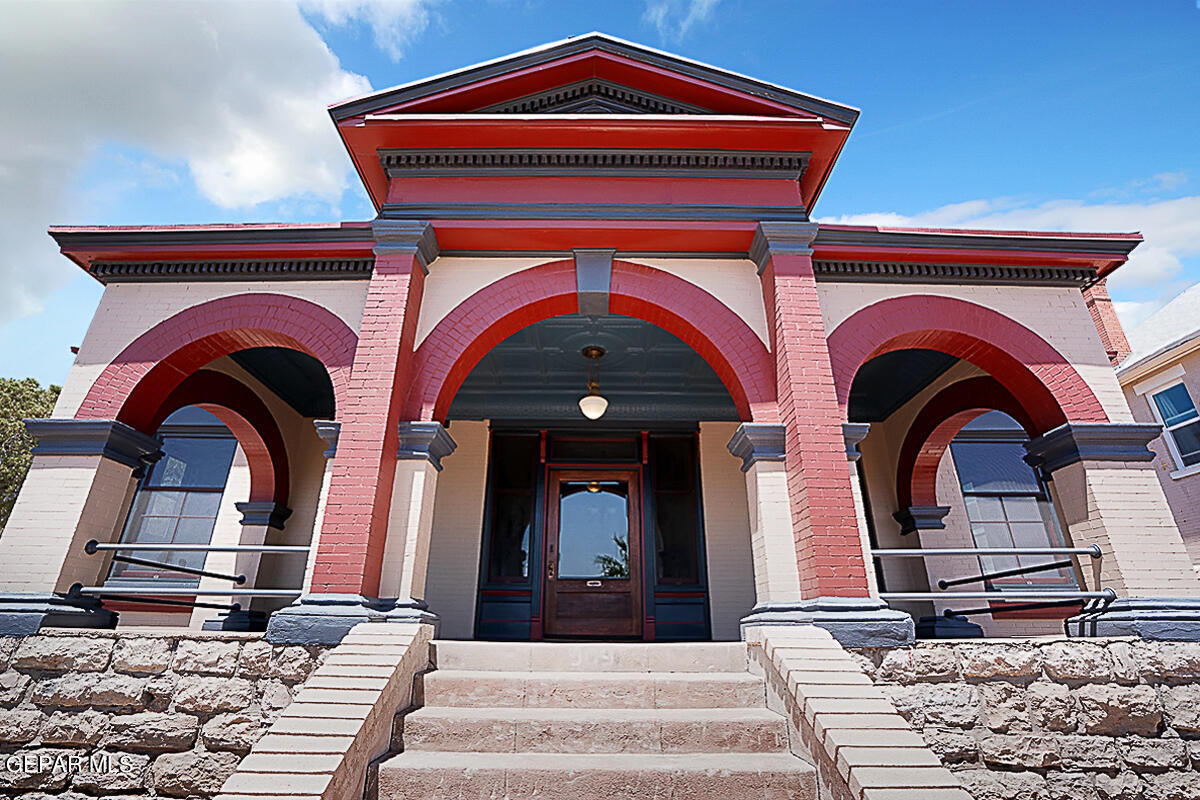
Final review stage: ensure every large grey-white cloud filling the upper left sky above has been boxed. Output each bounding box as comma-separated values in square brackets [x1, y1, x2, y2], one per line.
[0, 0, 433, 325]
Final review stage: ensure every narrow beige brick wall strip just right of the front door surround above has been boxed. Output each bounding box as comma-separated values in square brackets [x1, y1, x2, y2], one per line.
[700, 422, 755, 642]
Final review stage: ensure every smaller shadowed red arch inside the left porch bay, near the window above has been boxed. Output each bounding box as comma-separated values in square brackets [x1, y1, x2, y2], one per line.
[151, 369, 290, 506]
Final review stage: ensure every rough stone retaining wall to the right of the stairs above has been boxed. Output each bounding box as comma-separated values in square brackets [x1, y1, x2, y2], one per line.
[856, 639, 1200, 800]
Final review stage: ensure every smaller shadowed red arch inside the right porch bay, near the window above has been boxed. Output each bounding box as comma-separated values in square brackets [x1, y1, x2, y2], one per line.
[896, 375, 1037, 509]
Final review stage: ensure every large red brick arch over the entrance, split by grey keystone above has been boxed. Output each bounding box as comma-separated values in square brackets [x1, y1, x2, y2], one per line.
[406, 260, 775, 420]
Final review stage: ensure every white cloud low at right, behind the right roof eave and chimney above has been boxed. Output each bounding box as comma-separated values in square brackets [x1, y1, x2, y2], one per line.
[822, 194, 1200, 303]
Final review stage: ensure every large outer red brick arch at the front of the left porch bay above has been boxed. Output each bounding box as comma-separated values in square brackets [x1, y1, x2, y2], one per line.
[76, 294, 358, 433]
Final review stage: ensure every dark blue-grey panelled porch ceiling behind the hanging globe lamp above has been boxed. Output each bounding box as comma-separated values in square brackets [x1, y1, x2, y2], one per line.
[449, 314, 738, 426]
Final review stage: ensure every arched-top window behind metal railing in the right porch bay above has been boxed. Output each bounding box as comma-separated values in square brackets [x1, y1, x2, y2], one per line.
[950, 411, 1076, 589]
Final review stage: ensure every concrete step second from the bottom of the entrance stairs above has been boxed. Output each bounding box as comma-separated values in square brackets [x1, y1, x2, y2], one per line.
[401, 706, 787, 753]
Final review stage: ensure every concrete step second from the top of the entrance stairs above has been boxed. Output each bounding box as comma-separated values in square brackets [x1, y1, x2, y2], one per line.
[419, 669, 766, 709]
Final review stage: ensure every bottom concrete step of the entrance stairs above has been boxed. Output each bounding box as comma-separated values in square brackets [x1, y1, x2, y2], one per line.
[378, 751, 817, 800]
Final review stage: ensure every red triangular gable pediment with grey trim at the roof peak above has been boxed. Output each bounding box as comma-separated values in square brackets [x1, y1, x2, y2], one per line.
[330, 34, 858, 126]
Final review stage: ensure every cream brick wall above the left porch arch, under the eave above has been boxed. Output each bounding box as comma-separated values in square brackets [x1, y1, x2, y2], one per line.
[54, 281, 367, 417]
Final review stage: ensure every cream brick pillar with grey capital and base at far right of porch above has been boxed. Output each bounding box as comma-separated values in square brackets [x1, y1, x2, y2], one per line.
[1026, 423, 1200, 640]
